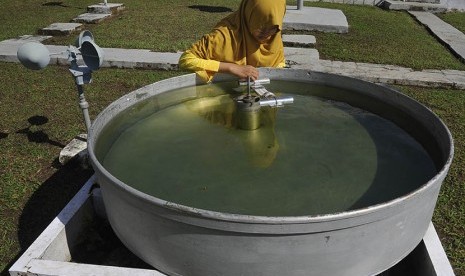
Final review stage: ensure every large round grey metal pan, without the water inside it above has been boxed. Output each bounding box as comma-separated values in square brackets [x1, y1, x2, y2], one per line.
[88, 68, 453, 276]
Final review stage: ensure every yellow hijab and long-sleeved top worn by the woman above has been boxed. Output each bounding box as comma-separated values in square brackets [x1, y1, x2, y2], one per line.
[190, 0, 286, 71]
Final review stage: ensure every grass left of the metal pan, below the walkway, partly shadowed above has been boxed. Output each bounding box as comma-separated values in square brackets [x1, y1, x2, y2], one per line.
[0, 63, 182, 272]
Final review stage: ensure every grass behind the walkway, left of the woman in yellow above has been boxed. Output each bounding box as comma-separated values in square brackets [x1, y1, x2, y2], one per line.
[0, 0, 240, 52]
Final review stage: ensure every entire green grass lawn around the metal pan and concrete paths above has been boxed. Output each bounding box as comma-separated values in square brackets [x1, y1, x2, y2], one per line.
[0, 0, 465, 275]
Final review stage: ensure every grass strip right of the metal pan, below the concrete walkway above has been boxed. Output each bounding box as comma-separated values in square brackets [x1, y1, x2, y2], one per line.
[401, 87, 465, 275]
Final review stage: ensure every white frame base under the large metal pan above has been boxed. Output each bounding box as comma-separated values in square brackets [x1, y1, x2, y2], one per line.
[9, 176, 455, 276]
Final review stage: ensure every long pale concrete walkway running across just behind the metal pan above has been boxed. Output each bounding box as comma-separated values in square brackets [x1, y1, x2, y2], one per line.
[0, 38, 465, 89]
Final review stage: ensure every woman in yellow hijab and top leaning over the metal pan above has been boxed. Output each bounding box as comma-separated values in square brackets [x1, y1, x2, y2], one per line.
[179, 0, 286, 82]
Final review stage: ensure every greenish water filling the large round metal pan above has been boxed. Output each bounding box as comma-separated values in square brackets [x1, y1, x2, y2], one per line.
[103, 82, 435, 216]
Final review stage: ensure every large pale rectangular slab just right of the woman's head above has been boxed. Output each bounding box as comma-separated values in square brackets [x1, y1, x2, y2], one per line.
[283, 6, 349, 33]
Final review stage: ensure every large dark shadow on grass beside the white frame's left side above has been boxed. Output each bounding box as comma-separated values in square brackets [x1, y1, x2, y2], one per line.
[0, 160, 93, 276]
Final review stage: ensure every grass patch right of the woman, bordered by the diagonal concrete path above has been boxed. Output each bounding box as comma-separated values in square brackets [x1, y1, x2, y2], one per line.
[305, 2, 465, 70]
